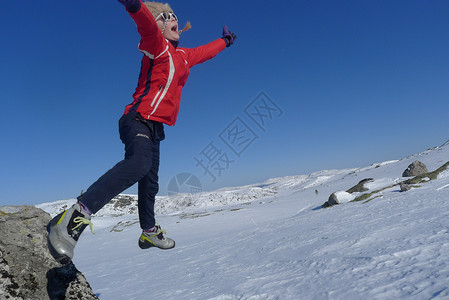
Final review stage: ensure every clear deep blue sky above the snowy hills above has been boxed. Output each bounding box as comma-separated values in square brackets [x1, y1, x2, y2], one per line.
[0, 0, 449, 205]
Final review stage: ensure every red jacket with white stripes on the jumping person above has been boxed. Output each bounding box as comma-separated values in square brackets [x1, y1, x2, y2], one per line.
[125, 5, 226, 126]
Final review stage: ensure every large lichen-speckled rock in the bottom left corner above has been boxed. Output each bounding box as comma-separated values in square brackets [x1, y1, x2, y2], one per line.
[0, 206, 98, 300]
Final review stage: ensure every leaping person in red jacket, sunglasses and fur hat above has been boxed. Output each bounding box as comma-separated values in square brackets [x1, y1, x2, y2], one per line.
[48, 0, 236, 264]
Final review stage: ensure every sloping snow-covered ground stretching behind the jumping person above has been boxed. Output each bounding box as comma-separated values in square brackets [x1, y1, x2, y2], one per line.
[39, 143, 449, 300]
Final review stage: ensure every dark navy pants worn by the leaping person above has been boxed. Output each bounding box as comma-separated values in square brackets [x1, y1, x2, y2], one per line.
[78, 112, 165, 229]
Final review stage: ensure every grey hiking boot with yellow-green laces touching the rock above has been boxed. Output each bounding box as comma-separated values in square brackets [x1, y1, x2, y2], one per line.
[47, 203, 93, 265]
